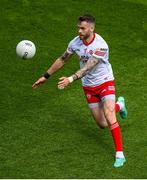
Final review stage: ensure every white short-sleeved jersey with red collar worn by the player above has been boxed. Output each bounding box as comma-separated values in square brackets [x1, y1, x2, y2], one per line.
[67, 33, 114, 87]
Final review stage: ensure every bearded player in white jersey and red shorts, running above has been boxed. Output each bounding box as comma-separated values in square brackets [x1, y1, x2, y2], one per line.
[32, 15, 127, 167]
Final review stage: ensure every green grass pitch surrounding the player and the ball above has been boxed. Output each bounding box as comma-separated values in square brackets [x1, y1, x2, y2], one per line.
[0, 0, 147, 179]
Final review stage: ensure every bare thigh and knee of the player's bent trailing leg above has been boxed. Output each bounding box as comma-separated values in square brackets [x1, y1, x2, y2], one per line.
[90, 105, 108, 128]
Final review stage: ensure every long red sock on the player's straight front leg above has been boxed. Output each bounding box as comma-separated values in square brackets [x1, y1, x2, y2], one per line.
[110, 122, 123, 151]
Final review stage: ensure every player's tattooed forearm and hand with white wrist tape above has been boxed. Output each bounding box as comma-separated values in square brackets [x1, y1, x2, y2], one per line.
[58, 57, 99, 89]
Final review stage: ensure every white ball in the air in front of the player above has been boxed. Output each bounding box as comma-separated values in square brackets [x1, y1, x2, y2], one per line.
[16, 40, 36, 59]
